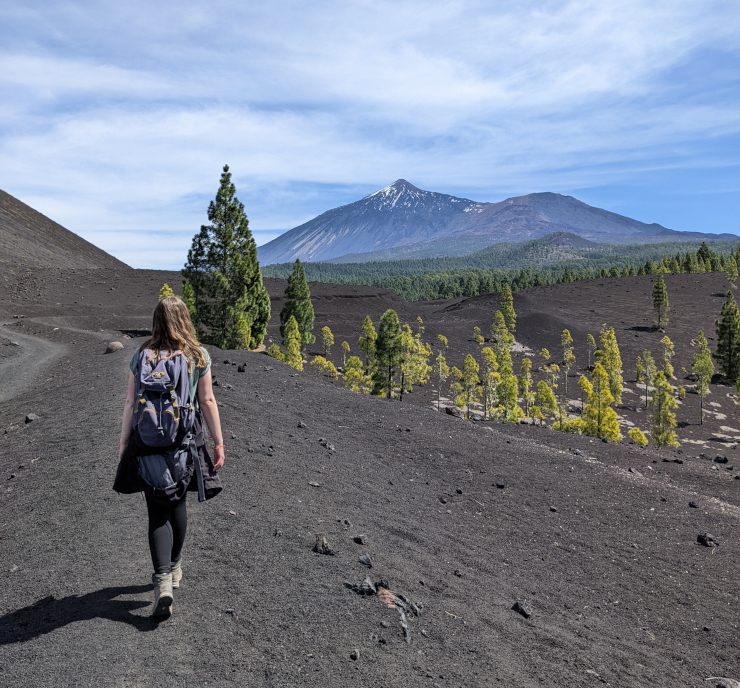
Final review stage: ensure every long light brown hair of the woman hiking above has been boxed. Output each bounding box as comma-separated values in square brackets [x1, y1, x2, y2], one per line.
[139, 296, 207, 374]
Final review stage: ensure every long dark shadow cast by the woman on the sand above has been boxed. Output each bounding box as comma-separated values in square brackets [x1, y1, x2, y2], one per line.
[0, 585, 158, 646]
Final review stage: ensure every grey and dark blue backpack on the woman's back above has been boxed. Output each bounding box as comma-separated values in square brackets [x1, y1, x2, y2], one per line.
[131, 349, 195, 449]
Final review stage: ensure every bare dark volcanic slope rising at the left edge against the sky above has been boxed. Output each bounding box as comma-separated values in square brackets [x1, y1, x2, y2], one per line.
[0, 191, 130, 273]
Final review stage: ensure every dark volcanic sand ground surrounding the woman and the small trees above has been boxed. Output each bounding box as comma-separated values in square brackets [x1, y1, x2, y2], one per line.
[0, 268, 740, 687]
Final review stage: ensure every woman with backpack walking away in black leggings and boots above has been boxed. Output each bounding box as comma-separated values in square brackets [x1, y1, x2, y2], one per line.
[113, 296, 224, 618]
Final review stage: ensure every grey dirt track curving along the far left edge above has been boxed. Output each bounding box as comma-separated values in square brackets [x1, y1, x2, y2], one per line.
[0, 320, 67, 402]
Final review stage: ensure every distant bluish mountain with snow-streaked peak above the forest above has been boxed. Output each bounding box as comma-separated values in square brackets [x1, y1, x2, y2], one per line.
[258, 179, 736, 265]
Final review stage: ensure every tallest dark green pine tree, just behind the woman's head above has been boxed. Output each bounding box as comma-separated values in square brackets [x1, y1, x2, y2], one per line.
[182, 165, 270, 349]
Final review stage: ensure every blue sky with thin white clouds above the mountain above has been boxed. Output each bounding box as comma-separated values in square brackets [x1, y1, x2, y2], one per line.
[0, 0, 740, 269]
